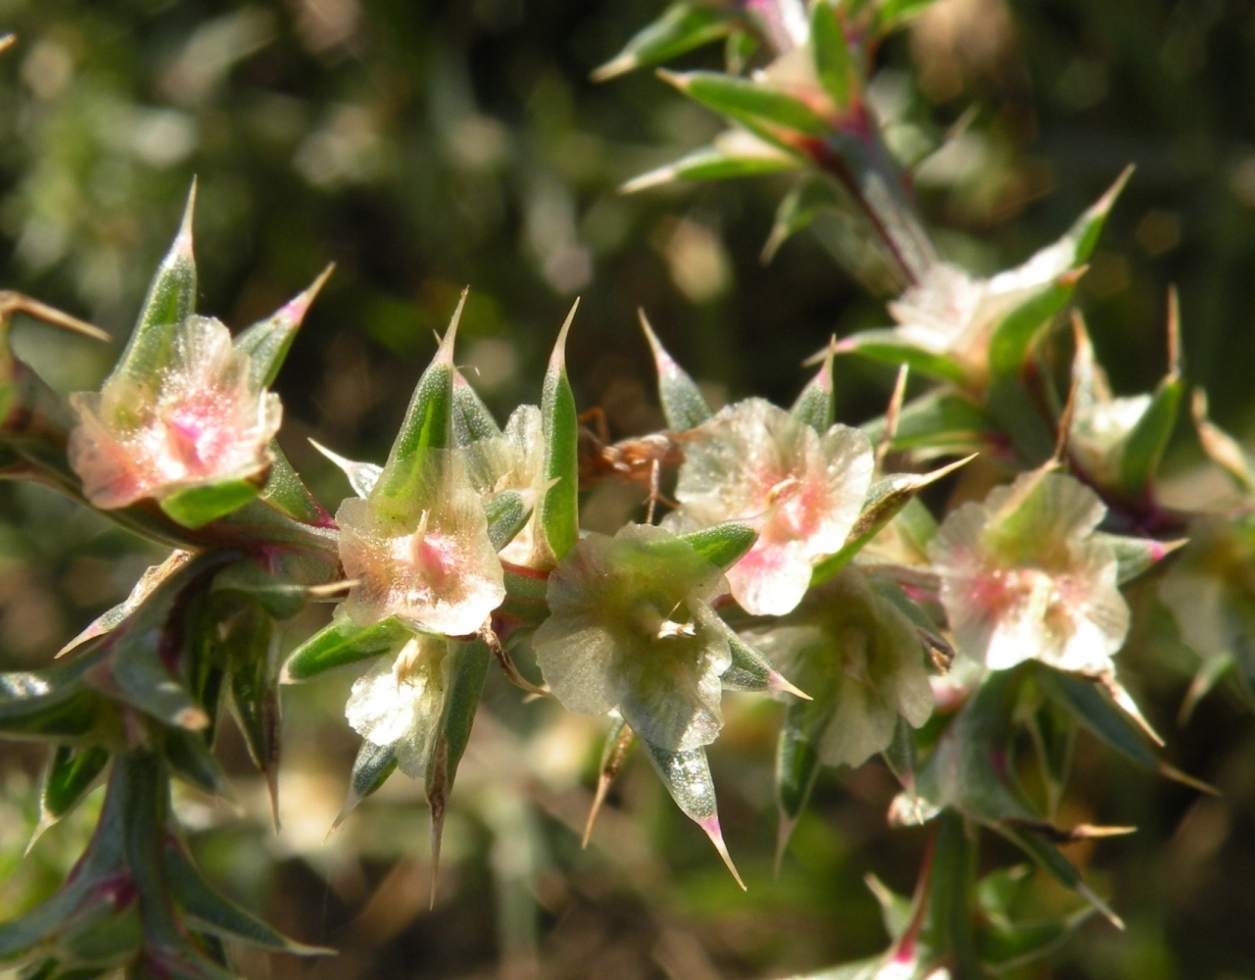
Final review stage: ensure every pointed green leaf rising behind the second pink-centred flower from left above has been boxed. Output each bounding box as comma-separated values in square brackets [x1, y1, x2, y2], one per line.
[371, 291, 467, 498]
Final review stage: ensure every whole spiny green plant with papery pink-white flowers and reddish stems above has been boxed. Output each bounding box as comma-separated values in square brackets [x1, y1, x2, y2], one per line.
[0, 0, 1239, 977]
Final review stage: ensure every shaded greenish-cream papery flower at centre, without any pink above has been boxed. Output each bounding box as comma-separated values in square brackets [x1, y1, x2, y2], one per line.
[532, 525, 732, 752]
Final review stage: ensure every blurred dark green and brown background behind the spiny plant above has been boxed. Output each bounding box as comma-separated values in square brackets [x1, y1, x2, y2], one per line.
[0, 0, 1255, 980]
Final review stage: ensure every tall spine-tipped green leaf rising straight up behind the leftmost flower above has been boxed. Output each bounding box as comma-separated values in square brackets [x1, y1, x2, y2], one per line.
[114, 181, 196, 381]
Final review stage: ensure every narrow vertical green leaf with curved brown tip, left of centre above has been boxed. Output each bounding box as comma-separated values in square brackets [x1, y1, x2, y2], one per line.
[538, 302, 580, 562]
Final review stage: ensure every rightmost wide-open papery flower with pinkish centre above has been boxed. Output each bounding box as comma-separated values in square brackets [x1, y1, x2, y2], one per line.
[929, 469, 1128, 674]
